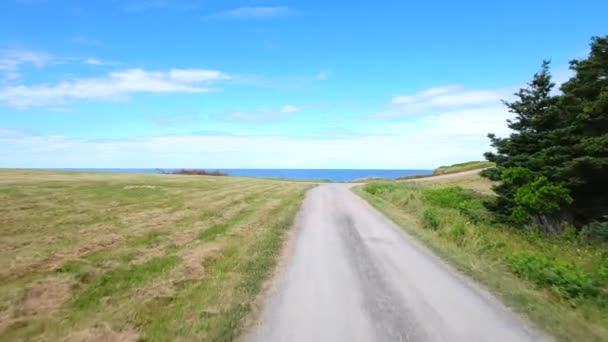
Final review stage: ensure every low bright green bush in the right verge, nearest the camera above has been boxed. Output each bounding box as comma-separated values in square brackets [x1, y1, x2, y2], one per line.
[507, 253, 598, 298]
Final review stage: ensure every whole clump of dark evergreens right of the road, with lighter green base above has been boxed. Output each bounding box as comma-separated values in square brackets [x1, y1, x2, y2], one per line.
[483, 36, 608, 232]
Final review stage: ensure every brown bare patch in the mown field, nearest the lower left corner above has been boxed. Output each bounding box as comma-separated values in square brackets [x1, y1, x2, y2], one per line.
[15, 278, 70, 316]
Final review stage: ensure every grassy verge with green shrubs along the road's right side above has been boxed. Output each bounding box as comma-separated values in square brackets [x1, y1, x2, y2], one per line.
[355, 175, 608, 341]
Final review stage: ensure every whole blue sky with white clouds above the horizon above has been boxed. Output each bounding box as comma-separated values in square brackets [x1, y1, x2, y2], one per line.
[0, 0, 608, 168]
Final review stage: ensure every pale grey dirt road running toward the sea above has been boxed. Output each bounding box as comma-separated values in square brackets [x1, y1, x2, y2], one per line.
[245, 184, 544, 342]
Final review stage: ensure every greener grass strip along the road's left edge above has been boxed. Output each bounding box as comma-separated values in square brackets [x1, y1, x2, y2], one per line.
[138, 190, 305, 341]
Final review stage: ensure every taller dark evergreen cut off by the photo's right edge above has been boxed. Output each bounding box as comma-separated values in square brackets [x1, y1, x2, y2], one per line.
[556, 36, 608, 223]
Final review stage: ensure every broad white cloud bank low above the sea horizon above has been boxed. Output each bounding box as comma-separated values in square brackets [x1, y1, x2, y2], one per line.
[0, 100, 511, 168]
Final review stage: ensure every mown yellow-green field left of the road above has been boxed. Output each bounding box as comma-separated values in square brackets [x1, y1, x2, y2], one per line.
[0, 170, 312, 341]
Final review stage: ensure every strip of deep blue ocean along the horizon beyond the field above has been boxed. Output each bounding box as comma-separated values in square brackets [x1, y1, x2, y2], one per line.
[45, 168, 433, 182]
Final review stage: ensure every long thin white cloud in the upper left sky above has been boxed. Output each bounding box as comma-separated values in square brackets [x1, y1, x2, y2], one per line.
[0, 69, 230, 109]
